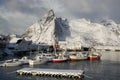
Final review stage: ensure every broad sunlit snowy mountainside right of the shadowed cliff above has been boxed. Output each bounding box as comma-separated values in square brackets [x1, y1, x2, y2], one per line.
[69, 19, 120, 46]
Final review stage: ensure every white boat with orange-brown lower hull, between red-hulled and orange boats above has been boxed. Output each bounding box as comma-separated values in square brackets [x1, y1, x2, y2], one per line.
[69, 52, 88, 61]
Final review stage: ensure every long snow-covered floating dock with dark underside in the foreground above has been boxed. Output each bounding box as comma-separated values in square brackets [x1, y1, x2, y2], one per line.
[16, 68, 84, 80]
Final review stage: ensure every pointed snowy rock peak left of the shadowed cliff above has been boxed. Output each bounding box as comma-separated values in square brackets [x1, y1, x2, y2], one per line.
[23, 10, 55, 44]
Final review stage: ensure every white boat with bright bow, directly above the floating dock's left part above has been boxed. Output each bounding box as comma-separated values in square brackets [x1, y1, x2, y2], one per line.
[29, 56, 48, 65]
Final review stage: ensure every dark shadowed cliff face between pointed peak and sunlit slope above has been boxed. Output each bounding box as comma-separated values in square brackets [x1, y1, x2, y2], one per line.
[55, 18, 71, 41]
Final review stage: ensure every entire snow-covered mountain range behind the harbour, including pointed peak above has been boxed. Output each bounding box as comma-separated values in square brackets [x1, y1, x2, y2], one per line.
[23, 10, 120, 46]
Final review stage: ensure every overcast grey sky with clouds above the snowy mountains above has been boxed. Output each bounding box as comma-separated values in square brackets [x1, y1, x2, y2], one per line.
[0, 0, 120, 34]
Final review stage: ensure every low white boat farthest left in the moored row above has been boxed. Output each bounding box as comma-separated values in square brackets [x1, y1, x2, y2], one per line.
[1, 59, 22, 67]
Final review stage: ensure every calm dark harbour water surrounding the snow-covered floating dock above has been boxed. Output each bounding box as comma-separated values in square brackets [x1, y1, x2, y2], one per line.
[0, 52, 120, 80]
